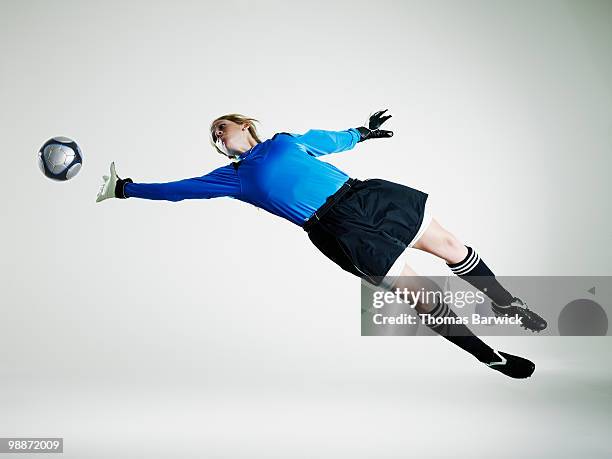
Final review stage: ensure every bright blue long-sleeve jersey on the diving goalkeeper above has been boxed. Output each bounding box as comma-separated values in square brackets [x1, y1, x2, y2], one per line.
[124, 129, 360, 226]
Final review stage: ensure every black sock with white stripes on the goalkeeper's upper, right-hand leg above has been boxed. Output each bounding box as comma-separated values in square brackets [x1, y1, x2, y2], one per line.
[447, 245, 514, 306]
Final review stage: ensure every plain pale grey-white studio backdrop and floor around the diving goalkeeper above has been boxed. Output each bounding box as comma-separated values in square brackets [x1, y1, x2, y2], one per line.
[0, 0, 612, 458]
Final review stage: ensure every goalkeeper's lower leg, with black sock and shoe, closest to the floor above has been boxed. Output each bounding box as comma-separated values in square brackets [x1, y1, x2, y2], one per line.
[389, 265, 535, 378]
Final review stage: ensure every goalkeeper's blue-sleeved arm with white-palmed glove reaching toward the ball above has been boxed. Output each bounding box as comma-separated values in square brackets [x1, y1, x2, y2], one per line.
[96, 163, 240, 202]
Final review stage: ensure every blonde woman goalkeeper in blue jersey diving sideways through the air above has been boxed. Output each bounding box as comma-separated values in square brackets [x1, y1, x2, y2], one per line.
[97, 110, 546, 378]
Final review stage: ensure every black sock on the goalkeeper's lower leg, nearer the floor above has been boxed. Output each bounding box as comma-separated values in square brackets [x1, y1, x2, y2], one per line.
[421, 301, 499, 363]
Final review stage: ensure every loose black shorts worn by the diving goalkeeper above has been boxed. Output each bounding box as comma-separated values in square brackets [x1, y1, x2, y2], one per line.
[304, 179, 428, 286]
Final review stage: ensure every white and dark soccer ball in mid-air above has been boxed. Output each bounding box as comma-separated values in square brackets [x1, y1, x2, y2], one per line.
[38, 137, 83, 181]
